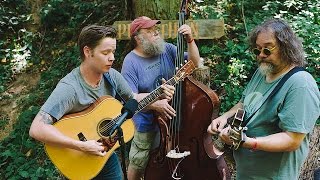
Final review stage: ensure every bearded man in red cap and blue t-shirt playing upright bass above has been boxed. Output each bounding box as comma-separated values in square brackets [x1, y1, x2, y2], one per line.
[121, 16, 200, 180]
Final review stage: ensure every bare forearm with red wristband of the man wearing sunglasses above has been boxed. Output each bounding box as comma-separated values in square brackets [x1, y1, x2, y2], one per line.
[242, 132, 305, 152]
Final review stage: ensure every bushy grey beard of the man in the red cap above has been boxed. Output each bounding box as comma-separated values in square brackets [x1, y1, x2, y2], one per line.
[138, 34, 165, 56]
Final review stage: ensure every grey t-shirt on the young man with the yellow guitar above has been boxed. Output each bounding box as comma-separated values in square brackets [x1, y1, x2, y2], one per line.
[41, 67, 133, 120]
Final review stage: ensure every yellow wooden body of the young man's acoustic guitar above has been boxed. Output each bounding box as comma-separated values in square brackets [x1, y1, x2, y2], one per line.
[45, 96, 134, 180]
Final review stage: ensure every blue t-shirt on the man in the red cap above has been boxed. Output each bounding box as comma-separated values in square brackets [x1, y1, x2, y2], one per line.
[121, 43, 186, 132]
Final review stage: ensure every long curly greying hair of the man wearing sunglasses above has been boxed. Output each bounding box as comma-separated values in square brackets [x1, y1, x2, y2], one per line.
[249, 19, 306, 67]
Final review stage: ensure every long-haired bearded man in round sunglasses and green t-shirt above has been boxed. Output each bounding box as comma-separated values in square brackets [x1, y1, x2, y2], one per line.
[208, 19, 320, 180]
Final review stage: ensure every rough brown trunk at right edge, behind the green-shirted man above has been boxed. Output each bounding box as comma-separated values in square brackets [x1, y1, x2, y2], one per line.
[299, 125, 320, 180]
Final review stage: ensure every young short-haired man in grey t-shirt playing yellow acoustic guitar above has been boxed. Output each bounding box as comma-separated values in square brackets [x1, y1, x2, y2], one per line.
[29, 25, 174, 180]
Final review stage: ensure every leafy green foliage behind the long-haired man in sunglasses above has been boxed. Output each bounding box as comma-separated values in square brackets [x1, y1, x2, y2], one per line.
[193, 0, 320, 113]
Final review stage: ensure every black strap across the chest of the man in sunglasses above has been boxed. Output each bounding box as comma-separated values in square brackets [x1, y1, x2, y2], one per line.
[243, 67, 305, 127]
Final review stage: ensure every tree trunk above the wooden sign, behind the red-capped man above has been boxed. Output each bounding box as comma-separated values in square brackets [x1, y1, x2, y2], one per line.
[132, 0, 180, 20]
